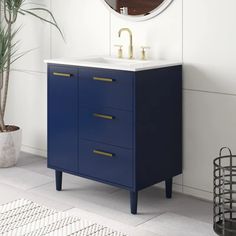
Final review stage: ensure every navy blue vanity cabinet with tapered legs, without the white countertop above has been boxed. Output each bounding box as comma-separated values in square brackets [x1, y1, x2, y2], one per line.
[48, 64, 182, 214]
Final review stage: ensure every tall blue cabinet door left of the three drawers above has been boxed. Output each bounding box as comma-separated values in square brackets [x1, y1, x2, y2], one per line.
[48, 66, 78, 172]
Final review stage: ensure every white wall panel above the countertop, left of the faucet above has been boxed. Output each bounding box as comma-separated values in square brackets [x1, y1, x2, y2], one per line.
[51, 0, 110, 58]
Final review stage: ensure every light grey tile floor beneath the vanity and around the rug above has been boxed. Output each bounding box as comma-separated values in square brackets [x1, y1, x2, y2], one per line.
[0, 153, 218, 236]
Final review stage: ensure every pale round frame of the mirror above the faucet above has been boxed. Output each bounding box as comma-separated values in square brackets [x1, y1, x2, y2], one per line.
[101, 0, 174, 21]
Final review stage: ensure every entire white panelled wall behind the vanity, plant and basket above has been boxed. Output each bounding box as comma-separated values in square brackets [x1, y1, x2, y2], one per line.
[7, 0, 236, 199]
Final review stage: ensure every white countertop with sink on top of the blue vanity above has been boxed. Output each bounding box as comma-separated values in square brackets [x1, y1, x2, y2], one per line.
[44, 56, 182, 71]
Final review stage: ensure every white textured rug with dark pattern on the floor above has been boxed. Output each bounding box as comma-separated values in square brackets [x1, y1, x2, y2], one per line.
[0, 199, 127, 236]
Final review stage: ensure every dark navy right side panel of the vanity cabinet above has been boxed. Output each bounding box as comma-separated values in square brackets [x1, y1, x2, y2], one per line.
[135, 66, 182, 190]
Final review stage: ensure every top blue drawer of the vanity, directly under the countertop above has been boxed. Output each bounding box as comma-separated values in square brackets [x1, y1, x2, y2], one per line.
[79, 68, 134, 110]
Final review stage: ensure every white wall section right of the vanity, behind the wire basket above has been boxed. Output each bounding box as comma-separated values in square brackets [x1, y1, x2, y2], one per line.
[183, 0, 236, 199]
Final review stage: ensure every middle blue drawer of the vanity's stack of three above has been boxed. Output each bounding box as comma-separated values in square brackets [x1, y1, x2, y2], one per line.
[79, 106, 133, 148]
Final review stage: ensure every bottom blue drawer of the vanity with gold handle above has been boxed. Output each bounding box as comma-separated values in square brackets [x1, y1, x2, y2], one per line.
[79, 140, 133, 187]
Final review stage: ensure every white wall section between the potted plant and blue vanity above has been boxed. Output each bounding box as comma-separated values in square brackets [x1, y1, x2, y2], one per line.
[6, 0, 50, 156]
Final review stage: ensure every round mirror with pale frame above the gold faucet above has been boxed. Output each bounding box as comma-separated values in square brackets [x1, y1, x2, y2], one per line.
[102, 0, 173, 21]
